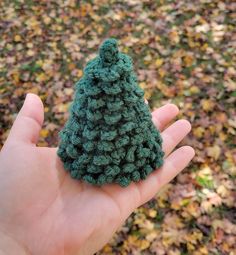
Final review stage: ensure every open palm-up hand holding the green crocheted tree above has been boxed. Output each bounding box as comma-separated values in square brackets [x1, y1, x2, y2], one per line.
[0, 94, 194, 255]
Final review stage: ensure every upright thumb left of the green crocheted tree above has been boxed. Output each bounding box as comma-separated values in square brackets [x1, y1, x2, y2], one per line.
[7, 93, 44, 144]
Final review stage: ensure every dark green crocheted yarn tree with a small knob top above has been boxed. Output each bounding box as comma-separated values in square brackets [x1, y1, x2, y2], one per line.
[58, 38, 164, 187]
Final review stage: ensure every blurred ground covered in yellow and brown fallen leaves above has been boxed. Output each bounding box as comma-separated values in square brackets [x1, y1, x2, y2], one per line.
[0, 0, 236, 255]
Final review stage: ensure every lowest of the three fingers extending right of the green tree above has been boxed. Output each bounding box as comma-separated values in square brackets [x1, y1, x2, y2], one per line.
[137, 146, 195, 205]
